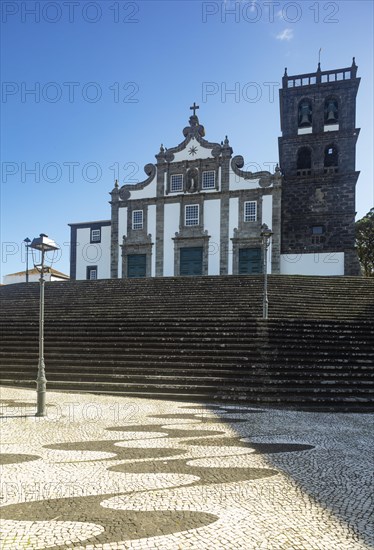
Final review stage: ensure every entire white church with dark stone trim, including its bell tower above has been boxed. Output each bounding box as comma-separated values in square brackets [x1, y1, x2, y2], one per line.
[70, 60, 360, 279]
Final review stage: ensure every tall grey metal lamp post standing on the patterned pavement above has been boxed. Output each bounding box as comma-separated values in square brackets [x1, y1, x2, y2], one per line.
[30, 233, 58, 416]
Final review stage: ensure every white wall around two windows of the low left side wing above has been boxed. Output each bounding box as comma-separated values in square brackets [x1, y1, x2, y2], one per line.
[76, 226, 110, 279]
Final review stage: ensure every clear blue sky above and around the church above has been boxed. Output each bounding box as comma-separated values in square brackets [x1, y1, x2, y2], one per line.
[1, 0, 374, 275]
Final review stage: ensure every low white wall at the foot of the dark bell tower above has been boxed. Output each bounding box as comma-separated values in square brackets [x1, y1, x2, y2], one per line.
[280, 252, 344, 276]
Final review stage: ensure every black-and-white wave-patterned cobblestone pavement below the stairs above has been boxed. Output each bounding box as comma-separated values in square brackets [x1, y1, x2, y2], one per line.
[0, 388, 374, 550]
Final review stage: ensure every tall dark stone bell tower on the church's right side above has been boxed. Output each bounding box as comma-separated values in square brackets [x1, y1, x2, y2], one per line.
[279, 58, 360, 275]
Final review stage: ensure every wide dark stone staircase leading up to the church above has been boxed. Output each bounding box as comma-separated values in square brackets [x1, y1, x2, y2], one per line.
[0, 275, 374, 411]
